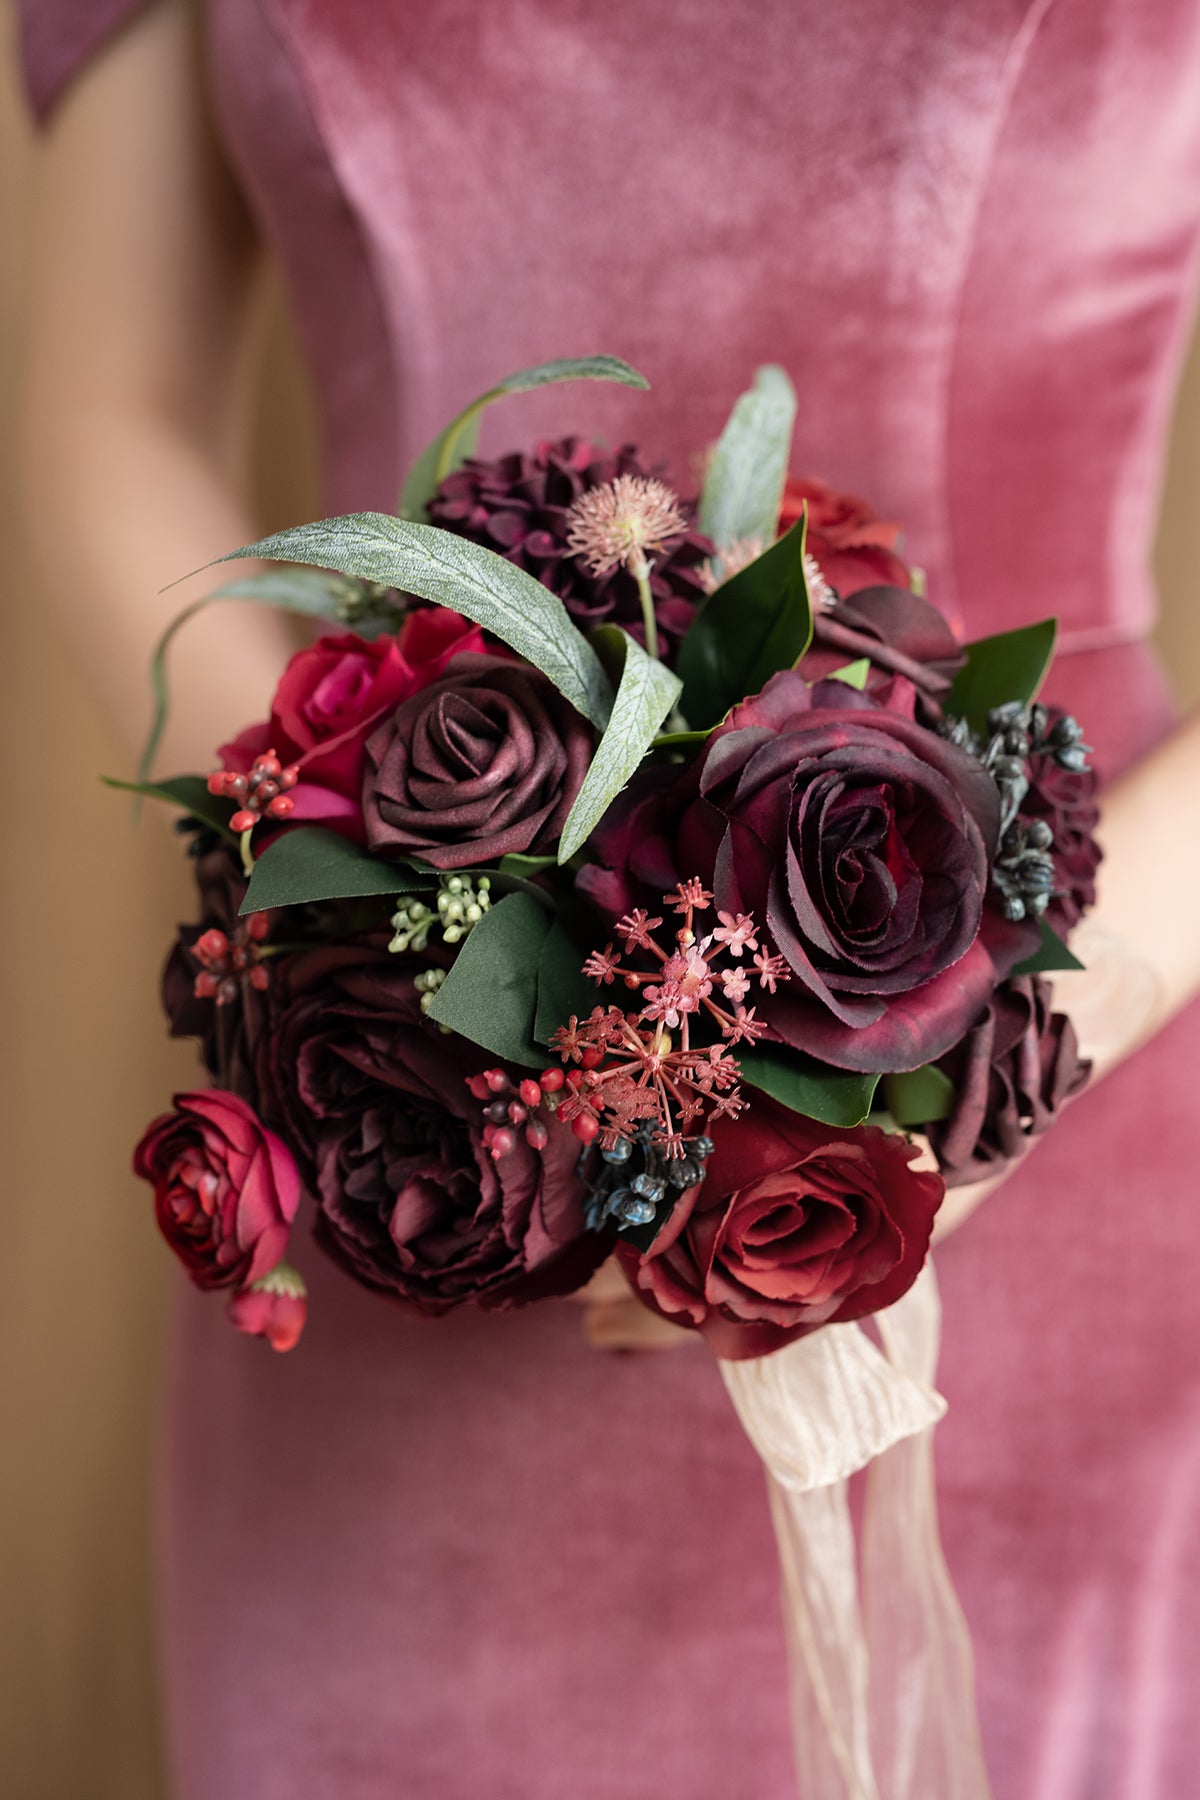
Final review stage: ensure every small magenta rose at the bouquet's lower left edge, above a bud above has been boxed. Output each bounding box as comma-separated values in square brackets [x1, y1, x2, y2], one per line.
[133, 1087, 300, 1287]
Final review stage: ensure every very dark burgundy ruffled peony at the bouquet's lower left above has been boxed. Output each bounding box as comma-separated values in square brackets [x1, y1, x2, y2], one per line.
[259, 947, 606, 1314]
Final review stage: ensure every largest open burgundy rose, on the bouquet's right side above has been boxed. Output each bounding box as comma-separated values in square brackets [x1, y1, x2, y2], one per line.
[579, 670, 999, 1071]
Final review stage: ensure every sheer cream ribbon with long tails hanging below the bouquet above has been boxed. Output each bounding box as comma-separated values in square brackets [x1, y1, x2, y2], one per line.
[720, 1262, 991, 1800]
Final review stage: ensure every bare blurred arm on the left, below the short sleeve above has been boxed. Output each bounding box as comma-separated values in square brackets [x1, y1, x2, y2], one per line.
[23, 0, 293, 770]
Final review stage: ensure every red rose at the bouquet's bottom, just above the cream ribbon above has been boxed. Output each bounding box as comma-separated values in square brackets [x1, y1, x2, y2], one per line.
[617, 1094, 945, 1359]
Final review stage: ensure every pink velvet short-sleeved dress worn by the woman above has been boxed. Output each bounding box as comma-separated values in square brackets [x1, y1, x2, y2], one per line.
[16, 0, 1200, 1800]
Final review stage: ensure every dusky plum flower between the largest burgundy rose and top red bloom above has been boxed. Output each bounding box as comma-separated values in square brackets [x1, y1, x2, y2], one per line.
[801, 587, 966, 715]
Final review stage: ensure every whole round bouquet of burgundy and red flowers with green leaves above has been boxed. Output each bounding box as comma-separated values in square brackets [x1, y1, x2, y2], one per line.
[119, 358, 1099, 1793]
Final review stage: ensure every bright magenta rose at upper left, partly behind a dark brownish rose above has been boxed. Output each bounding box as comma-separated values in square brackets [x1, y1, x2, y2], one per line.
[219, 607, 484, 841]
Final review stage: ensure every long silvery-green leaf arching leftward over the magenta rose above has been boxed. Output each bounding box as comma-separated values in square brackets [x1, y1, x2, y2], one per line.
[218, 513, 612, 729]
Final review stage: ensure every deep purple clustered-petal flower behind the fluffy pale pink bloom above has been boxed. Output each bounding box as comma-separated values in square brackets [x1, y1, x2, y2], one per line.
[428, 437, 712, 661]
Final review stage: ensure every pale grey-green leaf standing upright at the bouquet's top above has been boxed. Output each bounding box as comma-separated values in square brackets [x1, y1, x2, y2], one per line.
[698, 364, 795, 547]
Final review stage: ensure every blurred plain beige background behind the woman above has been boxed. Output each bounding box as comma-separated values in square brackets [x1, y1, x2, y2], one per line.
[0, 14, 1200, 1800]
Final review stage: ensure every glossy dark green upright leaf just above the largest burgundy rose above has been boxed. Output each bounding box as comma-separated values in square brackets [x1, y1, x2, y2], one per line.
[675, 520, 813, 727]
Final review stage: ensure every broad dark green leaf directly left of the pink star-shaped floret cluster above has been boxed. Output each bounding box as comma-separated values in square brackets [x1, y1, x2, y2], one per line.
[430, 893, 551, 1067]
